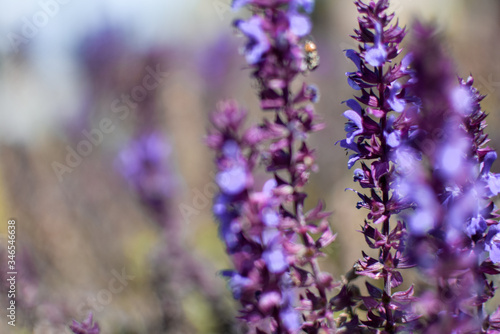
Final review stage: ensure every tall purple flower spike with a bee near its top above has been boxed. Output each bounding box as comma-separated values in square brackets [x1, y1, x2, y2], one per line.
[233, 0, 335, 333]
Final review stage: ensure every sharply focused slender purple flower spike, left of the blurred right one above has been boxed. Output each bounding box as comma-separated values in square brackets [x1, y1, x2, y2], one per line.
[338, 0, 414, 333]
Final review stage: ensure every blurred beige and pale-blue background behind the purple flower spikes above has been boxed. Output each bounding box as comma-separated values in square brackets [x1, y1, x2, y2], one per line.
[0, 0, 500, 334]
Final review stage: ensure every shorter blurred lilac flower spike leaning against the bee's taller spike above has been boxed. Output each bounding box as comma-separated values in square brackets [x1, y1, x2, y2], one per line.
[207, 102, 301, 333]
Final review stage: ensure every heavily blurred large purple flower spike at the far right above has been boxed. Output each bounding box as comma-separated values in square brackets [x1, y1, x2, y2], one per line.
[396, 25, 498, 333]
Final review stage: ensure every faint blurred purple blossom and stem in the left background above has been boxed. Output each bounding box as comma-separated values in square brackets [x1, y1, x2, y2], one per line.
[118, 129, 237, 333]
